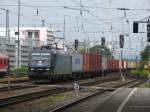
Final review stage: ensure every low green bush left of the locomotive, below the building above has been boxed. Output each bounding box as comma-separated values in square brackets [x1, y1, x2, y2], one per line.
[10, 67, 28, 77]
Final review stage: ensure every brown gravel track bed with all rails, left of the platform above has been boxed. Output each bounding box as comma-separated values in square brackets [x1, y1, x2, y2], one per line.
[0, 73, 145, 112]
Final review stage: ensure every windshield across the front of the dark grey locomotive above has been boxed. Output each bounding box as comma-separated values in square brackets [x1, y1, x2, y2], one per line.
[32, 53, 50, 61]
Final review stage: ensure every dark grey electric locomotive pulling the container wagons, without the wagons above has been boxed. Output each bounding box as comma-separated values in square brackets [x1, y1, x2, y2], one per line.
[28, 46, 71, 81]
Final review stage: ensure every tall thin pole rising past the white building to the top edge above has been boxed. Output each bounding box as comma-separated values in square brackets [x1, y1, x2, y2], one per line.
[17, 0, 20, 68]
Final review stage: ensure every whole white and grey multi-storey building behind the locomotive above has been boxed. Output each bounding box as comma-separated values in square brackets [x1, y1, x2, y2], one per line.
[0, 27, 54, 67]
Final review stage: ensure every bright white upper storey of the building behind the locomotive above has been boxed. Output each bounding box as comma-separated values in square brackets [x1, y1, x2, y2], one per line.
[0, 27, 54, 45]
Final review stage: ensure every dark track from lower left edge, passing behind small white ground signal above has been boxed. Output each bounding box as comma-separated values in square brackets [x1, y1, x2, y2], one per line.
[0, 77, 121, 107]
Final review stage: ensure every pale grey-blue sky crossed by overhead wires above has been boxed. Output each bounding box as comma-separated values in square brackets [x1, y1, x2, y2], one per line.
[0, 0, 150, 58]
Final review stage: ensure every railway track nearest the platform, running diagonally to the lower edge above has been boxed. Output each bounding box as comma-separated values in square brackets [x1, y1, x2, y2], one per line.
[49, 80, 145, 112]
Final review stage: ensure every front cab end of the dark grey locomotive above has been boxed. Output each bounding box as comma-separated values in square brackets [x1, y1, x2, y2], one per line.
[28, 48, 52, 79]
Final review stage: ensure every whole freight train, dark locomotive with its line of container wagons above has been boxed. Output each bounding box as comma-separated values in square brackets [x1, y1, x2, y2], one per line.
[28, 46, 137, 81]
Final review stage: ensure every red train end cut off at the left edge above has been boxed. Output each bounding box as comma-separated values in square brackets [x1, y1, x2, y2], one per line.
[0, 54, 9, 77]
